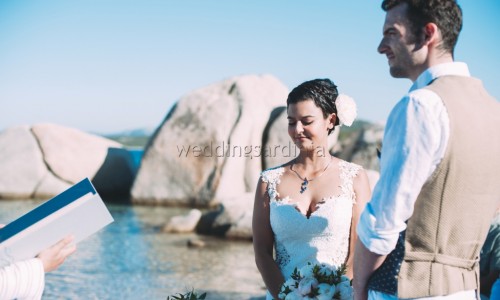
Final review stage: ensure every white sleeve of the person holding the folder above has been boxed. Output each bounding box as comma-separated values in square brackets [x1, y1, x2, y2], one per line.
[0, 258, 45, 300]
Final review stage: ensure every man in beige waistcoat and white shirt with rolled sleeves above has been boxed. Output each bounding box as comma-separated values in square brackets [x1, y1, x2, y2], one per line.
[354, 0, 500, 299]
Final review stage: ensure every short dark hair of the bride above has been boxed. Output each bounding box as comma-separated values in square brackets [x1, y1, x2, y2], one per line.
[286, 79, 339, 134]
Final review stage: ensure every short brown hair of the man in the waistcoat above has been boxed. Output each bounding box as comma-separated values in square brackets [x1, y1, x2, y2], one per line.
[382, 0, 462, 55]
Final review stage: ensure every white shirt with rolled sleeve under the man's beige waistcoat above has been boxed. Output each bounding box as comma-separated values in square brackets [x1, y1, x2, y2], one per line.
[357, 62, 476, 300]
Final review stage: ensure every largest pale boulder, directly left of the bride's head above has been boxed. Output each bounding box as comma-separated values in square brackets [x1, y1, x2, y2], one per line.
[132, 75, 288, 206]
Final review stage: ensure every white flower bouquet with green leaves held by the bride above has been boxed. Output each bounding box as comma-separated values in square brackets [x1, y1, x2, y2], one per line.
[278, 263, 354, 300]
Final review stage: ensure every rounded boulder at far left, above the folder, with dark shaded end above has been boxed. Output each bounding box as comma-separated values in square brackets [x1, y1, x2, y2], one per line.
[0, 123, 135, 198]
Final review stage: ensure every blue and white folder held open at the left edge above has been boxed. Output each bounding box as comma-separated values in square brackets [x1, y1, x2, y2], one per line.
[0, 178, 113, 267]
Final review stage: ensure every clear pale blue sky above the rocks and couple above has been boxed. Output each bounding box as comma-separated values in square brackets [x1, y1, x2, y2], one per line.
[0, 0, 500, 133]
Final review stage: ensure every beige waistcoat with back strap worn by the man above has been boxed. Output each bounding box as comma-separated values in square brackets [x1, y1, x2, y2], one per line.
[398, 76, 500, 298]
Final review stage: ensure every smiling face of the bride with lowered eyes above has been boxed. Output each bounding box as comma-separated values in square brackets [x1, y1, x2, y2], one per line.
[287, 100, 335, 150]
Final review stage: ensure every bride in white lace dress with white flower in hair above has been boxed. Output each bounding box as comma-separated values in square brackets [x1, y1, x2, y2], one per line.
[252, 79, 370, 299]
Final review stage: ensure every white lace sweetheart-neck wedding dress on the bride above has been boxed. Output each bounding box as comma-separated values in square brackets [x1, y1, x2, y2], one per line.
[261, 161, 361, 299]
